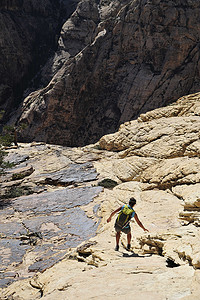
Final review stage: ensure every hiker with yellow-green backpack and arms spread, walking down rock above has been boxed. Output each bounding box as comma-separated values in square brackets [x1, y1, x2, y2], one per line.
[107, 198, 148, 251]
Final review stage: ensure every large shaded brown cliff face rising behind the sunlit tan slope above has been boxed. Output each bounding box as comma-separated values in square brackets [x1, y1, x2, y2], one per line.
[14, 0, 200, 146]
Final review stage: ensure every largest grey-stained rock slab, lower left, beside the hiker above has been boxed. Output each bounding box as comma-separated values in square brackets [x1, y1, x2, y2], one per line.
[0, 187, 102, 288]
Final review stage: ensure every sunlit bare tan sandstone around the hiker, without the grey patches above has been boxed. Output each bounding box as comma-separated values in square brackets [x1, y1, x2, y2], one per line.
[0, 95, 200, 300]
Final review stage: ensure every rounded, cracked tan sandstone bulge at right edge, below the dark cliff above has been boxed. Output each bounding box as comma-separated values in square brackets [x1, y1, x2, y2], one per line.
[99, 115, 200, 158]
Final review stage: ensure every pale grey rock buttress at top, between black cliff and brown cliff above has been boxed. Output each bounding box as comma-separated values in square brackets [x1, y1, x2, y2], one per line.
[42, 0, 99, 79]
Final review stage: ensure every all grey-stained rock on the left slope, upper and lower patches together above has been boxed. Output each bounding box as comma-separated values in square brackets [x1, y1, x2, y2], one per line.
[0, 146, 102, 287]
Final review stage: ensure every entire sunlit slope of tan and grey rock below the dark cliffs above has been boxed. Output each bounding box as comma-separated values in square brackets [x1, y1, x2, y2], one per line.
[0, 93, 200, 300]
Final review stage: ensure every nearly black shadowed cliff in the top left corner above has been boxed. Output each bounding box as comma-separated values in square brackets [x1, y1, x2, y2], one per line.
[0, 0, 76, 118]
